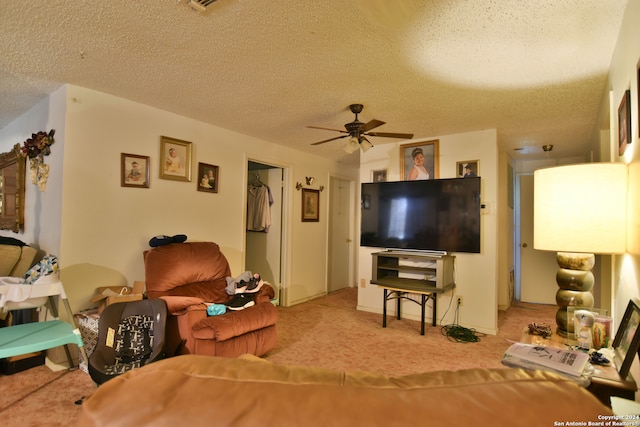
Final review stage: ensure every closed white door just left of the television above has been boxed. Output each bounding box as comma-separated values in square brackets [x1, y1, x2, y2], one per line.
[327, 177, 355, 292]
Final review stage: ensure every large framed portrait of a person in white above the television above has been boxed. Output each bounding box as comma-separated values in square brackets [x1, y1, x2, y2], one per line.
[400, 140, 439, 181]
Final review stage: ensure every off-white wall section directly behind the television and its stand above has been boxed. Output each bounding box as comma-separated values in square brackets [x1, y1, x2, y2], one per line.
[358, 129, 506, 334]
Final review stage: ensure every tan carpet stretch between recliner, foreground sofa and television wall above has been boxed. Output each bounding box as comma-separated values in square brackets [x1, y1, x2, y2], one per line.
[265, 289, 557, 375]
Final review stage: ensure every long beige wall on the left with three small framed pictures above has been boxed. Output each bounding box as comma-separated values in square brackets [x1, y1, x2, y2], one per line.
[0, 85, 357, 310]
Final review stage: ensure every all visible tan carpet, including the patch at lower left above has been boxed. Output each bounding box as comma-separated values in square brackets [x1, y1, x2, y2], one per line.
[0, 288, 556, 426]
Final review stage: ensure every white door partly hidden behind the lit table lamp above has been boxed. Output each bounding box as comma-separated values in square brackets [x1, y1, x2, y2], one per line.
[516, 175, 558, 304]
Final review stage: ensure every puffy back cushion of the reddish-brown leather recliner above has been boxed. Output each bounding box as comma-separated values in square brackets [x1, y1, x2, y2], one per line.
[143, 242, 231, 303]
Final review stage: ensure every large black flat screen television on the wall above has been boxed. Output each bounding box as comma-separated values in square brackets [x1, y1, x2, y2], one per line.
[360, 177, 481, 253]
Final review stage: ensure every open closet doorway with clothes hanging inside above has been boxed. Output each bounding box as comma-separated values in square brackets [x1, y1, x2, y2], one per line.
[244, 160, 285, 303]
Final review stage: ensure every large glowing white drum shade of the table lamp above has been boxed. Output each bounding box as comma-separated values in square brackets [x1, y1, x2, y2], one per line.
[533, 163, 627, 254]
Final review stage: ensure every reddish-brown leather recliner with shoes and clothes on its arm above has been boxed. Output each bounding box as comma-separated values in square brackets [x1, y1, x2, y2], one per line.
[144, 242, 278, 357]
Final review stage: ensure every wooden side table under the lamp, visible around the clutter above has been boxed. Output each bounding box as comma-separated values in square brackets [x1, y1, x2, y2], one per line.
[520, 328, 638, 407]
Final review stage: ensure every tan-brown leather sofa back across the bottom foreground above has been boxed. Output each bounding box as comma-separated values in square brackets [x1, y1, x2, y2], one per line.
[78, 355, 612, 427]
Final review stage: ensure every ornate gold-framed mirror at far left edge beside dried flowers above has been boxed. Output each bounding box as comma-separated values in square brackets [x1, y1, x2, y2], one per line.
[0, 144, 27, 233]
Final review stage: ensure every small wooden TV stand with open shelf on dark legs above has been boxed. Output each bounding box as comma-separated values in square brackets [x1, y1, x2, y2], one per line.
[371, 251, 455, 335]
